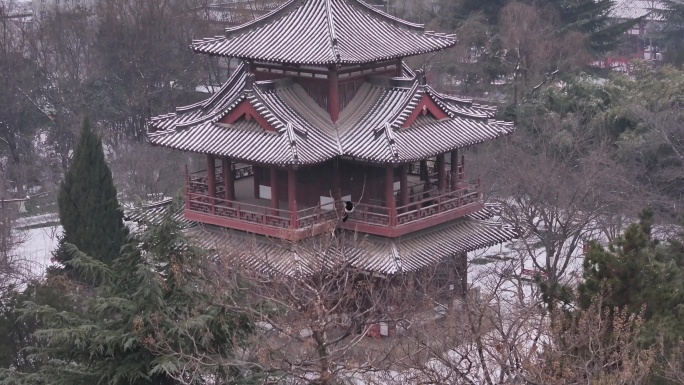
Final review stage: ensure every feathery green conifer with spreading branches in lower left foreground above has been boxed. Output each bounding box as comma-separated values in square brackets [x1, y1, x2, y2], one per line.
[0, 202, 253, 385]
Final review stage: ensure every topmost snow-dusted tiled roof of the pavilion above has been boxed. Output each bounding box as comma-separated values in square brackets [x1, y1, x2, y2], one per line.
[192, 0, 456, 65]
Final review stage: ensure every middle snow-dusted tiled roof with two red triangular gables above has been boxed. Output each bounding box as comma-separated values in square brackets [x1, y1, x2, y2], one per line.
[148, 63, 514, 165]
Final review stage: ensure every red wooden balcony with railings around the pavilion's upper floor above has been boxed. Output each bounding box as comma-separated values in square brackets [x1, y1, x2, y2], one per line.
[185, 166, 483, 239]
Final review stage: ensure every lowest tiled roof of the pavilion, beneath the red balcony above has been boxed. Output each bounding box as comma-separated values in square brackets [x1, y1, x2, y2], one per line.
[126, 200, 519, 275]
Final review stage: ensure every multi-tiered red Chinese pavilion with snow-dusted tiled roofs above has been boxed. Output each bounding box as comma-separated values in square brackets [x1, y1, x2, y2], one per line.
[148, 0, 516, 282]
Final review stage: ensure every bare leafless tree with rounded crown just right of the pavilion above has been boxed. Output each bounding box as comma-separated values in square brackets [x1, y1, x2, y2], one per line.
[484, 111, 643, 300]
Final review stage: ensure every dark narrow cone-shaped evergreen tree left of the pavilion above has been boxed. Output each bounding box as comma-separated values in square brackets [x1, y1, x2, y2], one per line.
[54, 119, 128, 274]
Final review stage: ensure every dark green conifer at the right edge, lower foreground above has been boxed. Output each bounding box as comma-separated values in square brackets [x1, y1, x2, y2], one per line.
[578, 211, 684, 384]
